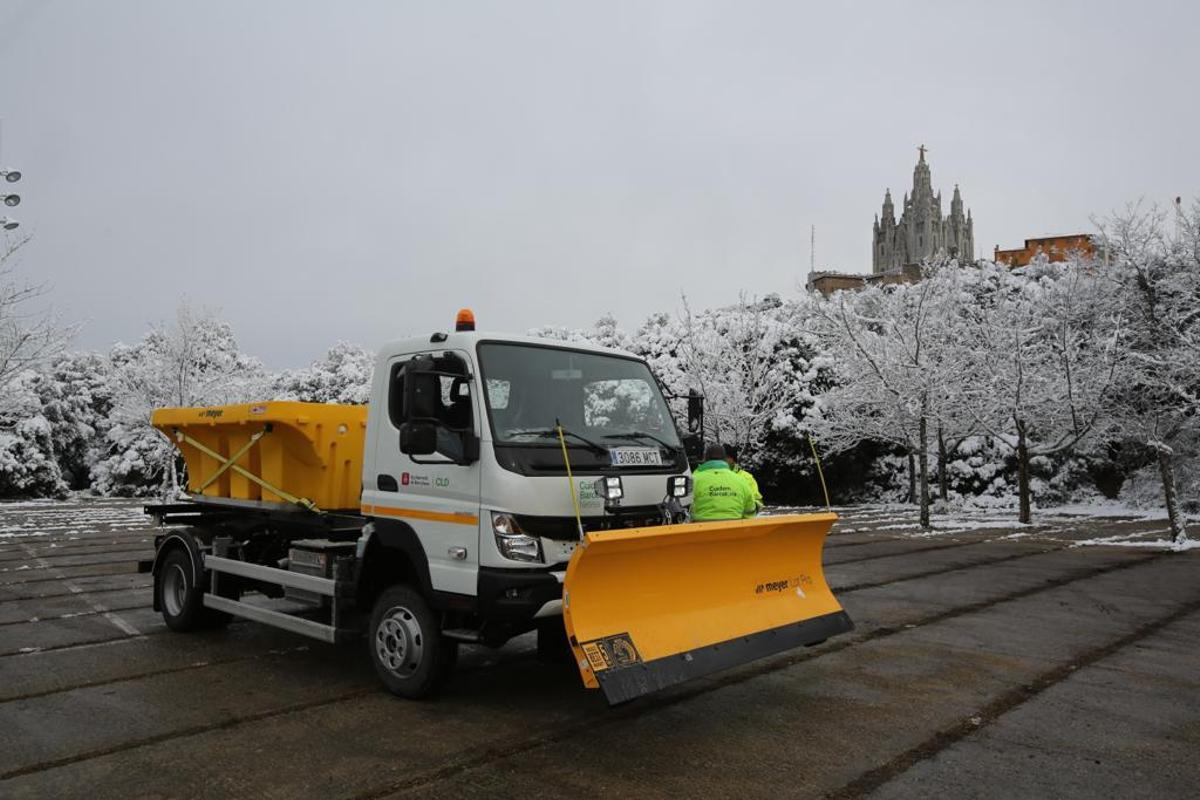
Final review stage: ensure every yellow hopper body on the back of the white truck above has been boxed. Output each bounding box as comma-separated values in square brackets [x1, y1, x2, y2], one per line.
[150, 401, 367, 511]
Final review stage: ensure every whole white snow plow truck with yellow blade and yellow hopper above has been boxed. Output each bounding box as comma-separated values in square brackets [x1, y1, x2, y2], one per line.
[143, 309, 852, 704]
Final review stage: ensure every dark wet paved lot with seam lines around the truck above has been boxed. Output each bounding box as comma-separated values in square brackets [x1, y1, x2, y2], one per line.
[0, 503, 1200, 800]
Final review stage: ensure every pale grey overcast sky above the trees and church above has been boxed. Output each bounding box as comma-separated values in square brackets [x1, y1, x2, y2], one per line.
[0, 0, 1200, 367]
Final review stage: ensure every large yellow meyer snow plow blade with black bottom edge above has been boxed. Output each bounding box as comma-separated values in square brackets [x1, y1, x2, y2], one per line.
[563, 513, 853, 703]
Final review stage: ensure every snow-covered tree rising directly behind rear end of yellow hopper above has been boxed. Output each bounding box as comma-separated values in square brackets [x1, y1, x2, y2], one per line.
[92, 302, 270, 495]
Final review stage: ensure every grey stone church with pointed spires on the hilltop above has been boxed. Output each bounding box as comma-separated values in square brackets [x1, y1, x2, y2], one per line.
[871, 145, 974, 275]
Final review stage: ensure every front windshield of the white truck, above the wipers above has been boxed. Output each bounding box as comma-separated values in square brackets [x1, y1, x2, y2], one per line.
[479, 343, 682, 449]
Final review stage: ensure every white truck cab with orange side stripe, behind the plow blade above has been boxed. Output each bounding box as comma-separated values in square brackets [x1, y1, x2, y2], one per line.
[360, 330, 690, 676]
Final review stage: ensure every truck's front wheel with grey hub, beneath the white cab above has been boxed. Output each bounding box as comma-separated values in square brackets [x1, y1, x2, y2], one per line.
[367, 584, 458, 699]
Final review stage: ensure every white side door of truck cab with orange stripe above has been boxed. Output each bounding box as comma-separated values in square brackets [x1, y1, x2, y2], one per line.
[364, 351, 480, 595]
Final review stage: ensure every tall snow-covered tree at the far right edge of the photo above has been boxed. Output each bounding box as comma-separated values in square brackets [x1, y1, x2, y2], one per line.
[1100, 201, 1200, 542]
